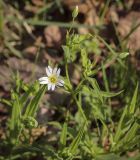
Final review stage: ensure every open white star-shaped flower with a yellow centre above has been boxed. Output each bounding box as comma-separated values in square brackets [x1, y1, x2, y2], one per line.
[39, 66, 64, 91]
